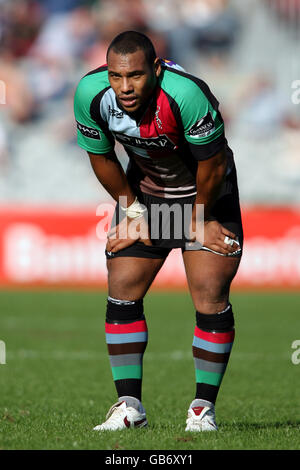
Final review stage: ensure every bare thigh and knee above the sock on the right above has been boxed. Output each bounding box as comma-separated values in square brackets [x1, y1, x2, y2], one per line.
[183, 250, 240, 313]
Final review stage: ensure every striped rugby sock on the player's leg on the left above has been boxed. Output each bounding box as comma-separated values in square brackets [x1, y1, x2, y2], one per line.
[105, 297, 148, 400]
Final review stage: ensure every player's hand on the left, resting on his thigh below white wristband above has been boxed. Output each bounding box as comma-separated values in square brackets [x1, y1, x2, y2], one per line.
[106, 216, 152, 253]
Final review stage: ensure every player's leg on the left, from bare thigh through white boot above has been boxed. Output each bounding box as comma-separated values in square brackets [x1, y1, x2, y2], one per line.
[95, 250, 165, 431]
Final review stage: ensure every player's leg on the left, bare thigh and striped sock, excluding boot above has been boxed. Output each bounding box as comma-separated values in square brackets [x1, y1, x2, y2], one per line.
[106, 253, 164, 400]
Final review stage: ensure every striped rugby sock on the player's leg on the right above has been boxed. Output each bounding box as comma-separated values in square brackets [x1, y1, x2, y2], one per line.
[193, 304, 235, 406]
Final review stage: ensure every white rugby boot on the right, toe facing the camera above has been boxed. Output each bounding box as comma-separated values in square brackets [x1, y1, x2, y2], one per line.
[185, 400, 218, 432]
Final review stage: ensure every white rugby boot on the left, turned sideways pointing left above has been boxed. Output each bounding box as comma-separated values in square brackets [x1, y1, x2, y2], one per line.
[94, 397, 148, 431]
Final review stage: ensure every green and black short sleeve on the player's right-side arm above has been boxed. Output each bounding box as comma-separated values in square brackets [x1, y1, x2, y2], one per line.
[181, 80, 226, 160]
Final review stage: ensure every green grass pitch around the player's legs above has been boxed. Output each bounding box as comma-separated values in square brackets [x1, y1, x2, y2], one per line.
[0, 291, 300, 450]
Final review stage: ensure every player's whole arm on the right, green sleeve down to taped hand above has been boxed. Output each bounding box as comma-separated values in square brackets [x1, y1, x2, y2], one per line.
[181, 81, 236, 254]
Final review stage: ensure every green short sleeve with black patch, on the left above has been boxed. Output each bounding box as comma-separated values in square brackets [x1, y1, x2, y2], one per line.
[74, 78, 114, 154]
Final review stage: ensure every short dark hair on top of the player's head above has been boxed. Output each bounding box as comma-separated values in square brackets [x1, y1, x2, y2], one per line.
[106, 31, 157, 65]
